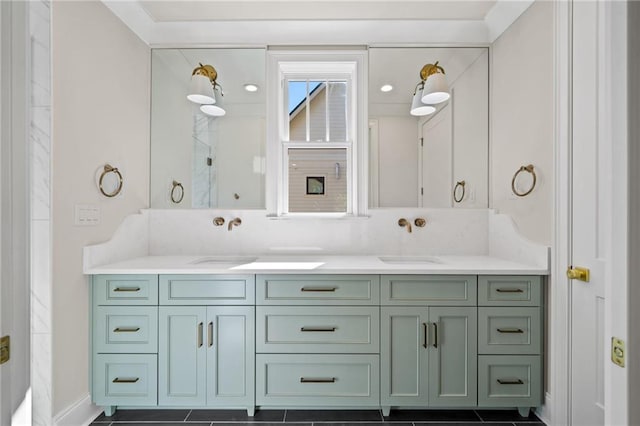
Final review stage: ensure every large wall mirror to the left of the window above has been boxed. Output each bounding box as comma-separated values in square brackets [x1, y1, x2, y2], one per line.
[150, 49, 266, 209]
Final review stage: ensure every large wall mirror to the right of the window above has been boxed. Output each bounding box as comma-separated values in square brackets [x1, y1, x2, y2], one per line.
[369, 48, 489, 208]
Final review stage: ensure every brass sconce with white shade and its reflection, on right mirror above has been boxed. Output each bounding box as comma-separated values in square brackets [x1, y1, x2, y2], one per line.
[409, 61, 451, 116]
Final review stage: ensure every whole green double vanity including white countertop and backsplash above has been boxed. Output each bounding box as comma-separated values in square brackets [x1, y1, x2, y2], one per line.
[84, 209, 549, 415]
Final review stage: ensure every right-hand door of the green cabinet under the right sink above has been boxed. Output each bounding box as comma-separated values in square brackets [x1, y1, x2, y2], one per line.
[429, 307, 478, 407]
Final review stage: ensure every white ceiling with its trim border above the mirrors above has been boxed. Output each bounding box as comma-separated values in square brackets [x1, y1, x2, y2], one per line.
[102, 0, 534, 47]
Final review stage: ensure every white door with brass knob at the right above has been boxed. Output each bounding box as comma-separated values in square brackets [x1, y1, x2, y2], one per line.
[569, 1, 611, 426]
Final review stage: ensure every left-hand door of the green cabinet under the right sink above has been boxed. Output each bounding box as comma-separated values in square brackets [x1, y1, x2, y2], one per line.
[380, 307, 429, 407]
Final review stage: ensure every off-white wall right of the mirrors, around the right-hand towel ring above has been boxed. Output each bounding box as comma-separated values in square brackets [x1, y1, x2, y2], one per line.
[489, 0, 553, 245]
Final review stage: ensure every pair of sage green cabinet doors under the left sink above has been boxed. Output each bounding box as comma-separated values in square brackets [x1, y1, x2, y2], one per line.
[158, 306, 255, 413]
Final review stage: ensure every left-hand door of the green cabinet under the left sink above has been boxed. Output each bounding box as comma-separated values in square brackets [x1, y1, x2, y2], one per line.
[158, 306, 207, 406]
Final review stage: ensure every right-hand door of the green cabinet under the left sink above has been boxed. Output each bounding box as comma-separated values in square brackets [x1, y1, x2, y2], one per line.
[205, 306, 255, 407]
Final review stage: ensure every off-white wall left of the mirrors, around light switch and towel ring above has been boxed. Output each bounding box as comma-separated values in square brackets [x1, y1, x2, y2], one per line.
[51, 1, 150, 415]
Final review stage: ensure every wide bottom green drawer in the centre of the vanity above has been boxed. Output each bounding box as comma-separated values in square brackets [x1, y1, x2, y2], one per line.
[256, 355, 380, 407]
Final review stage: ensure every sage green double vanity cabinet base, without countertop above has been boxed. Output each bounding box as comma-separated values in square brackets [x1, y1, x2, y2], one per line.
[90, 274, 543, 415]
